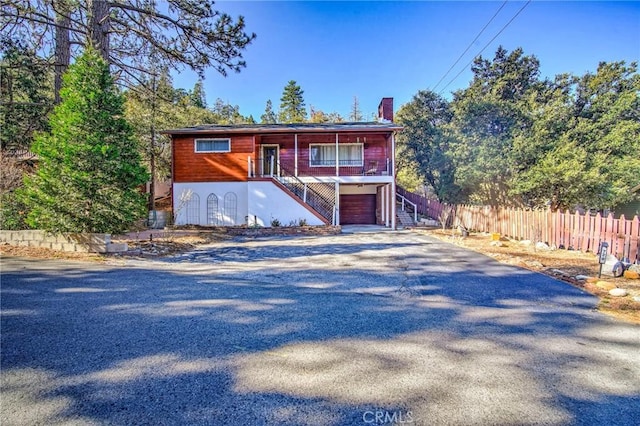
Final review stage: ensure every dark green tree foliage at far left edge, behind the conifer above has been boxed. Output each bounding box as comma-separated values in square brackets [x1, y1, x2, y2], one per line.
[0, 38, 53, 151]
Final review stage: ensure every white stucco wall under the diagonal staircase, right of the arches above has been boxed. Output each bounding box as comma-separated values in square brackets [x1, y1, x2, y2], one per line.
[247, 181, 323, 226]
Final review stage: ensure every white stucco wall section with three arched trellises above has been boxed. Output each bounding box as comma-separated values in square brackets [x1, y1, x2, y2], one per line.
[173, 182, 248, 226]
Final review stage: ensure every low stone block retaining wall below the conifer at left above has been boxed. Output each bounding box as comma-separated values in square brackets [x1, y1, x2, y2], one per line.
[0, 230, 127, 253]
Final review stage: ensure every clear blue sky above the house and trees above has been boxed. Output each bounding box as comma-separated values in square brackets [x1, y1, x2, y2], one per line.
[174, 1, 640, 120]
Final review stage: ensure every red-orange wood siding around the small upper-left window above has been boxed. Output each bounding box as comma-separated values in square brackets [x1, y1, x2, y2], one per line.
[172, 135, 254, 182]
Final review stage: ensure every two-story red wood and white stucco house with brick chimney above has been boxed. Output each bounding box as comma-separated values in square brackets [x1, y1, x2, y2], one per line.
[164, 98, 401, 228]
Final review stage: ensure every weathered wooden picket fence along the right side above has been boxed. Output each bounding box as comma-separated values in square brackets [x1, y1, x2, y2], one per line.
[398, 187, 640, 262]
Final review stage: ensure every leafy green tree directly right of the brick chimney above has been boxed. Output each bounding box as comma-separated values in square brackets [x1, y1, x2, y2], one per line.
[396, 90, 461, 203]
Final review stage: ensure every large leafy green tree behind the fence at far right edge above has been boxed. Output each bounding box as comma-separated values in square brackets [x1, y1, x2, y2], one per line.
[512, 62, 640, 209]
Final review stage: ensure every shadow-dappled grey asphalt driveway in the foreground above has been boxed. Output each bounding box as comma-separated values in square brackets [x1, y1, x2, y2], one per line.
[0, 232, 640, 426]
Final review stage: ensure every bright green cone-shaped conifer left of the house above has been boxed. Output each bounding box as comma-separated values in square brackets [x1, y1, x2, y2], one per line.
[20, 48, 148, 233]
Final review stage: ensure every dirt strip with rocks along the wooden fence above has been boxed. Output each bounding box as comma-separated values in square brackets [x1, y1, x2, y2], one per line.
[415, 229, 640, 323]
